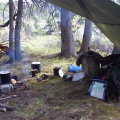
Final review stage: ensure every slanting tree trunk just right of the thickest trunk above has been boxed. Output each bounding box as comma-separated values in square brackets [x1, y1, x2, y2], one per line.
[80, 19, 92, 52]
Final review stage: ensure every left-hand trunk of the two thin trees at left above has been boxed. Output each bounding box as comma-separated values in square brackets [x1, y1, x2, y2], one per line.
[9, 0, 15, 63]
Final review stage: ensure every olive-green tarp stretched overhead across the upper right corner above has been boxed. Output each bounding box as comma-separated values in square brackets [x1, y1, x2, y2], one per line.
[45, 0, 120, 49]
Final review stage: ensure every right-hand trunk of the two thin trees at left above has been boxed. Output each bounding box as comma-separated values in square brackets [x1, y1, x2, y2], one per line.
[15, 0, 23, 61]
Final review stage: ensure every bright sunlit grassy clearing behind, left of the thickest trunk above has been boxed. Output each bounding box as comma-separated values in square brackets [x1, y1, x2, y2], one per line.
[22, 35, 60, 55]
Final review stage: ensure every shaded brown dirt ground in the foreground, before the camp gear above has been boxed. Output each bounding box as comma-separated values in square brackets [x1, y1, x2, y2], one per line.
[0, 75, 120, 120]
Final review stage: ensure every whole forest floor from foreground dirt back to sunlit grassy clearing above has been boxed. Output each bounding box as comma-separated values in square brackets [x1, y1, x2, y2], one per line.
[0, 37, 120, 120]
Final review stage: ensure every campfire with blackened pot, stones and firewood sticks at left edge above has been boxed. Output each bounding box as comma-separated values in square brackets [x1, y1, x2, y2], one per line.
[0, 71, 29, 112]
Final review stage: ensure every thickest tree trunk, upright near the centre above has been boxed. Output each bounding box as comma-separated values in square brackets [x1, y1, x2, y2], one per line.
[61, 9, 75, 57]
